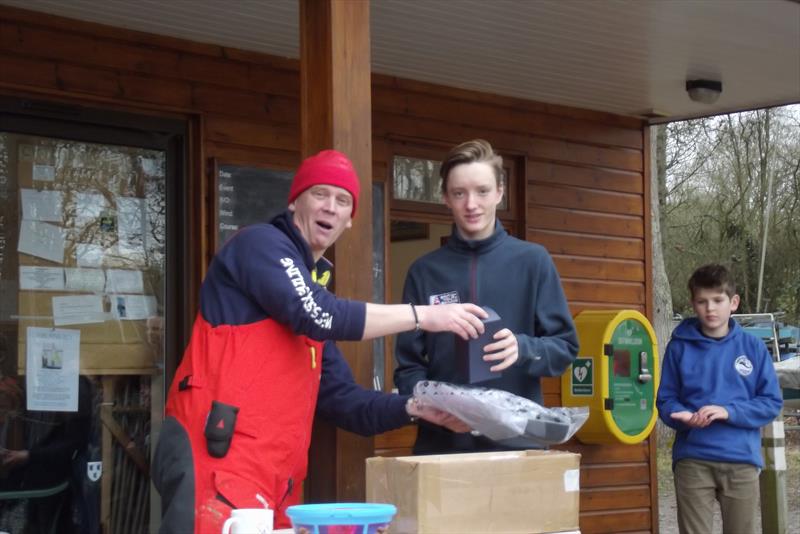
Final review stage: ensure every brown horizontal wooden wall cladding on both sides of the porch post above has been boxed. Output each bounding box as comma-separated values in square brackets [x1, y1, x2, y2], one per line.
[0, 7, 658, 534]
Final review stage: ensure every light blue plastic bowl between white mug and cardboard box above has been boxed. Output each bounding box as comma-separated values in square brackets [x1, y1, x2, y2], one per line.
[286, 503, 397, 534]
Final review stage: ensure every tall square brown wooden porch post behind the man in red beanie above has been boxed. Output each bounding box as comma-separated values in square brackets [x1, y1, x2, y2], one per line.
[300, 0, 373, 502]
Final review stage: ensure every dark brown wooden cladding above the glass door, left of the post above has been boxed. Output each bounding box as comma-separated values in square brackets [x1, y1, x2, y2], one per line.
[0, 7, 300, 171]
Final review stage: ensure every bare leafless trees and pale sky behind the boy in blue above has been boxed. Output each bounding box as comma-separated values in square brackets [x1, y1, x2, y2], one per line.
[656, 106, 800, 321]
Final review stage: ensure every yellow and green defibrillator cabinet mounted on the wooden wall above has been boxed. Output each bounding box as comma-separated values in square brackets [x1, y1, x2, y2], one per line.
[561, 310, 659, 444]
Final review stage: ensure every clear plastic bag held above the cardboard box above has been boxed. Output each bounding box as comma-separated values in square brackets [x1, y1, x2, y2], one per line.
[414, 380, 589, 448]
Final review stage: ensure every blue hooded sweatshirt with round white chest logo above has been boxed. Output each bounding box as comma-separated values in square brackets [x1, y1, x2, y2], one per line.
[656, 318, 783, 467]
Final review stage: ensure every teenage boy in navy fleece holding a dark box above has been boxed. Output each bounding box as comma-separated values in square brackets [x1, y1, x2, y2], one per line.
[394, 139, 578, 454]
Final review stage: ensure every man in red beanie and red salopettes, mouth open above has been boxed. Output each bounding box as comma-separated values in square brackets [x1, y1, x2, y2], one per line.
[153, 150, 486, 534]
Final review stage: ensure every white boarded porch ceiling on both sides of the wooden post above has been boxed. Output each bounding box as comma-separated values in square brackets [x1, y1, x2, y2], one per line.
[0, 0, 800, 120]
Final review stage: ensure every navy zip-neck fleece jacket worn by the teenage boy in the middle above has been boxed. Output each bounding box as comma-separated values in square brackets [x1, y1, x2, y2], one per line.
[394, 221, 578, 454]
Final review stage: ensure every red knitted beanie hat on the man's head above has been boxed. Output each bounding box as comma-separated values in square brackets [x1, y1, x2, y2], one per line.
[289, 150, 361, 217]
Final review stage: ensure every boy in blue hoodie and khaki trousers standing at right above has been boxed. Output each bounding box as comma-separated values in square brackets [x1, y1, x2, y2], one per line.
[656, 265, 783, 534]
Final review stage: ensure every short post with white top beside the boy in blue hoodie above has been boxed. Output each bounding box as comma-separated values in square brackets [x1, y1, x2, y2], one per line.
[759, 411, 788, 534]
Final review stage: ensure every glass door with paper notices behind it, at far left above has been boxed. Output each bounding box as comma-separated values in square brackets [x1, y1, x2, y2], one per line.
[0, 97, 186, 534]
